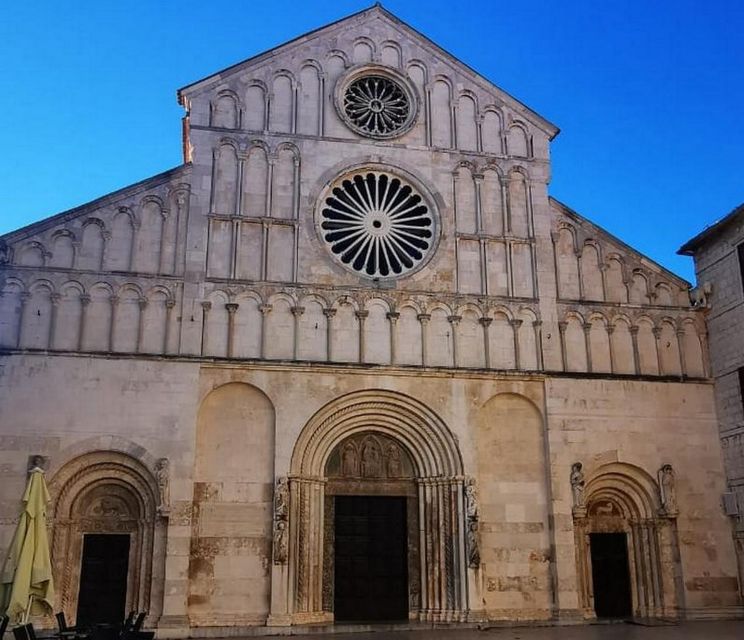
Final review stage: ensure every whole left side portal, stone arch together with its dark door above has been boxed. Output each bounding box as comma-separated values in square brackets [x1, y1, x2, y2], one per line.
[50, 451, 167, 625]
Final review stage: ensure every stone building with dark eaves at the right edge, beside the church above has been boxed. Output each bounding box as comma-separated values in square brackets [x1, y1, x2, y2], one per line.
[679, 205, 744, 600]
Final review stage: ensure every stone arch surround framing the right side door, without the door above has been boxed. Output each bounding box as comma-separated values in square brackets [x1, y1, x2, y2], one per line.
[573, 462, 680, 618]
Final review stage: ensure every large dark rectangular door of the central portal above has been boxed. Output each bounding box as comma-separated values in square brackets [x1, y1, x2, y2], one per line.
[334, 496, 408, 622]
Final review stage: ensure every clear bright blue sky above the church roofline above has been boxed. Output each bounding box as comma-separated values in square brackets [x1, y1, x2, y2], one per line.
[0, 0, 744, 279]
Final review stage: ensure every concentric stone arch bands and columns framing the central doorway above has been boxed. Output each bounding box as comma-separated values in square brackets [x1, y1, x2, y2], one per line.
[282, 390, 470, 624]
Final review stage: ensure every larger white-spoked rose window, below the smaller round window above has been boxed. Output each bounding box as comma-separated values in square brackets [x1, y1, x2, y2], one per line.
[316, 167, 437, 279]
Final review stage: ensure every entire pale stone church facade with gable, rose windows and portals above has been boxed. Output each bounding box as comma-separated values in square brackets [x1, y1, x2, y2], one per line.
[0, 6, 741, 637]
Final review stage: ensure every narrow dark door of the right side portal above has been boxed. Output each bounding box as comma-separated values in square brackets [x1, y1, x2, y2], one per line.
[589, 533, 633, 618]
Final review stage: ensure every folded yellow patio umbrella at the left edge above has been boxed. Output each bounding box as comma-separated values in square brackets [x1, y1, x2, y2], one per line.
[0, 469, 54, 624]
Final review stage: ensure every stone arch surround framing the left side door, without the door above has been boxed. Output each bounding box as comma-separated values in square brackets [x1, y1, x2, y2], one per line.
[49, 451, 167, 626]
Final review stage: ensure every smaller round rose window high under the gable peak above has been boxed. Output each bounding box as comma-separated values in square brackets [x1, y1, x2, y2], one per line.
[335, 65, 419, 140]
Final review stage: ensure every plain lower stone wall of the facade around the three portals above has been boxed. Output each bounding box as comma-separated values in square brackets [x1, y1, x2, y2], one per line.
[0, 355, 737, 626]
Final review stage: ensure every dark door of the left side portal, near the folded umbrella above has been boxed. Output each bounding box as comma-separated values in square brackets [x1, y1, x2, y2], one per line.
[76, 534, 129, 626]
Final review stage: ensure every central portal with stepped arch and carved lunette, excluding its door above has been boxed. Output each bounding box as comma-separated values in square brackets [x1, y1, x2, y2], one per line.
[288, 390, 468, 623]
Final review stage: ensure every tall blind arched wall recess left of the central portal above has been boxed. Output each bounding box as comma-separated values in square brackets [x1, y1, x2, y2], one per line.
[188, 382, 275, 626]
